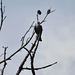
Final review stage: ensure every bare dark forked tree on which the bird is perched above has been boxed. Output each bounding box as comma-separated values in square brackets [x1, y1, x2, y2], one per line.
[0, 9, 57, 75]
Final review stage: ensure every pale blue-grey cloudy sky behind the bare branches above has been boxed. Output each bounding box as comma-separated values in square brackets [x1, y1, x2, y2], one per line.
[0, 0, 75, 75]
